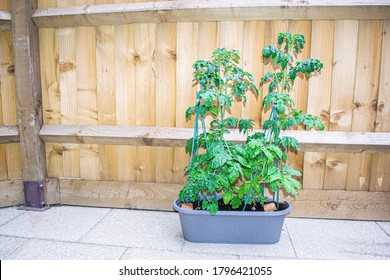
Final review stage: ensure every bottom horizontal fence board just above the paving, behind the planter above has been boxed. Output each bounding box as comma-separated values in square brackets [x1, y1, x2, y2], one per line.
[60, 179, 390, 221]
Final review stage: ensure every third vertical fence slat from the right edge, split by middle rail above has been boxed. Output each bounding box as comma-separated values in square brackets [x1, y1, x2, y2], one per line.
[324, 20, 358, 189]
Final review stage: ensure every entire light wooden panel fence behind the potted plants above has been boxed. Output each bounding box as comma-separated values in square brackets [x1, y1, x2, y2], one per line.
[0, 0, 390, 220]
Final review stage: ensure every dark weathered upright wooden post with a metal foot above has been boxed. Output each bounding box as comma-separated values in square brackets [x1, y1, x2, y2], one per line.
[11, 0, 46, 211]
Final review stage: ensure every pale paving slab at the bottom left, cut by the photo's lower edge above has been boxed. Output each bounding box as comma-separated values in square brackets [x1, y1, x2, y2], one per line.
[5, 239, 126, 260]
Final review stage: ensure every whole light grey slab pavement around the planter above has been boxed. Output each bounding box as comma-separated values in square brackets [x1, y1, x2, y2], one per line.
[0, 206, 390, 260]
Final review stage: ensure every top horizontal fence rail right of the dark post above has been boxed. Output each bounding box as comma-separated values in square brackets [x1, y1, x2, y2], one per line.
[33, 0, 390, 27]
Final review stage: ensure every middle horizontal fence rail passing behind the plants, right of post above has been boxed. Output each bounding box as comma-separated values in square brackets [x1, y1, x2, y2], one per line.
[40, 125, 390, 153]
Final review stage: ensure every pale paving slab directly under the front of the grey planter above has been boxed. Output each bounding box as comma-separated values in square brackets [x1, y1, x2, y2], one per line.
[183, 226, 296, 259]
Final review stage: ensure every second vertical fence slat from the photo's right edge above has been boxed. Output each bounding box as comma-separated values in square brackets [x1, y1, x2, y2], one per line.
[346, 20, 383, 191]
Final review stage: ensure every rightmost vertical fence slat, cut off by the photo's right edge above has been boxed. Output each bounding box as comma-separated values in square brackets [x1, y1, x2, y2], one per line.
[370, 20, 390, 192]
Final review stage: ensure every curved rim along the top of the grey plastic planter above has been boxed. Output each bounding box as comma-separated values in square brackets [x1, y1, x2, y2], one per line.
[173, 198, 292, 217]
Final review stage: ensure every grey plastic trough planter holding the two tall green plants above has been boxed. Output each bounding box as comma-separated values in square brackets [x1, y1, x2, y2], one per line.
[173, 199, 291, 244]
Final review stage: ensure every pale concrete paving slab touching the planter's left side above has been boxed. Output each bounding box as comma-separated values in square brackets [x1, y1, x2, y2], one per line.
[82, 209, 183, 251]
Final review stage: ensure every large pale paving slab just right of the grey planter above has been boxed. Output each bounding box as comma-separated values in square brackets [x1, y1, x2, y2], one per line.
[286, 218, 390, 260]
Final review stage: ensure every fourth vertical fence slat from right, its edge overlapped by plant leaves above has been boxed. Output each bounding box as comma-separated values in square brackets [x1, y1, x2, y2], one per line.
[303, 20, 334, 190]
